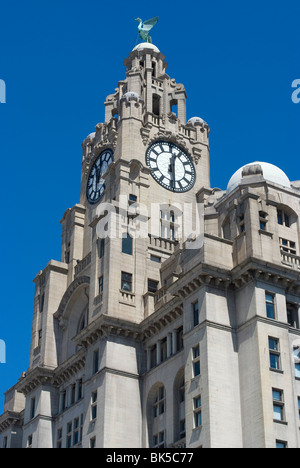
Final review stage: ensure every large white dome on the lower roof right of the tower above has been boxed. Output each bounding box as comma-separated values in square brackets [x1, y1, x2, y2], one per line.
[227, 162, 291, 193]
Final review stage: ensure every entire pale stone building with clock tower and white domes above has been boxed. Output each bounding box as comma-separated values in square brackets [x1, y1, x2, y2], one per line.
[0, 43, 300, 448]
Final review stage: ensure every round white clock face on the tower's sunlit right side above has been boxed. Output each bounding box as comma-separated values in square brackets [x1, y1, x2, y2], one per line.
[146, 141, 196, 192]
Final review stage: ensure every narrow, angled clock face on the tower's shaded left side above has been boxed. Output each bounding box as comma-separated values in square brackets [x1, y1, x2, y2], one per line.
[86, 149, 113, 204]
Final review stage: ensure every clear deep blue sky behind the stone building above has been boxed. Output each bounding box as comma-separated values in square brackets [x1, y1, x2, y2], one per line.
[0, 0, 300, 413]
